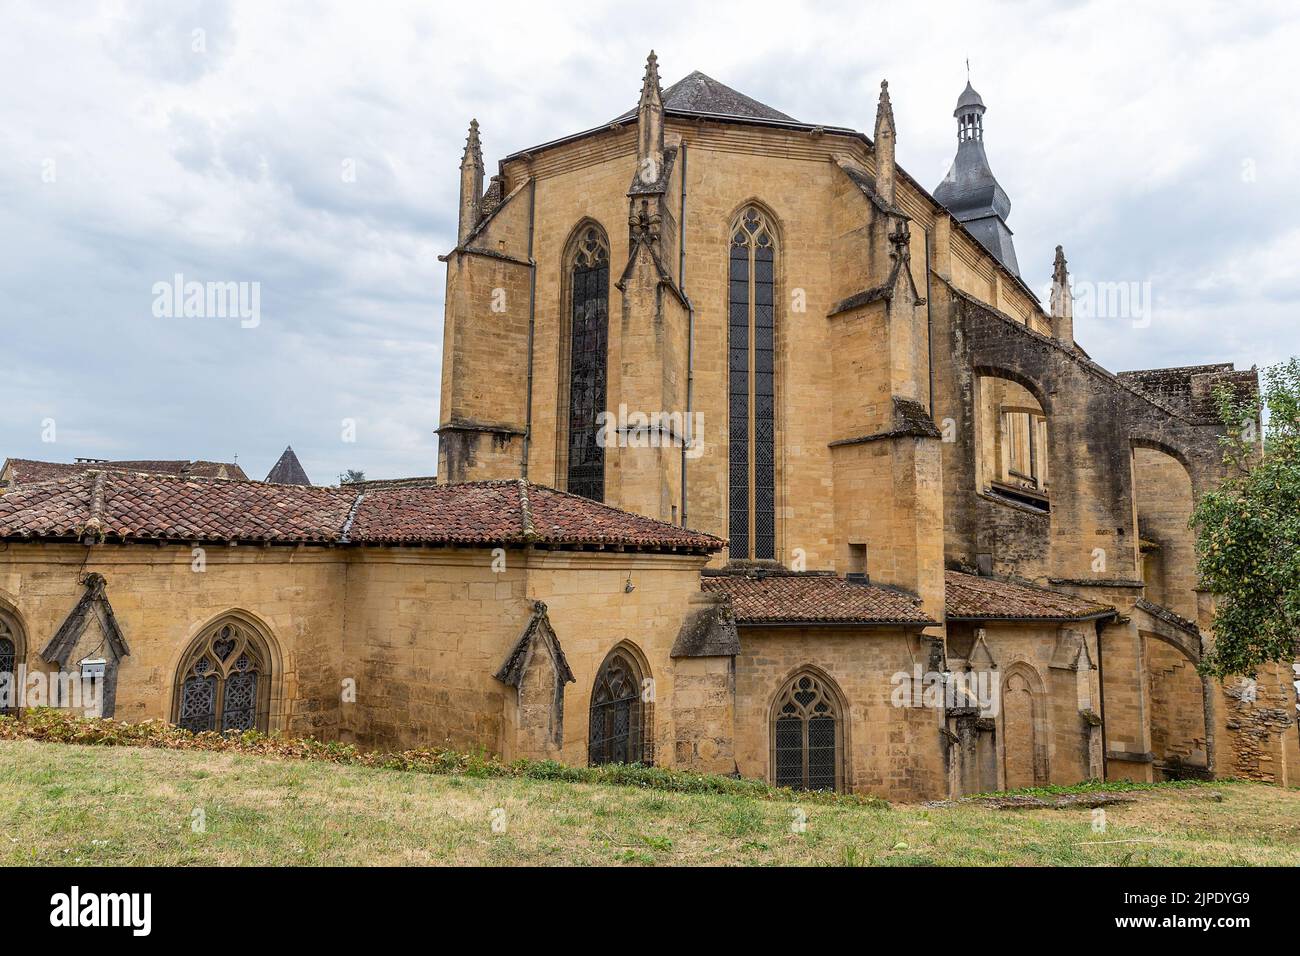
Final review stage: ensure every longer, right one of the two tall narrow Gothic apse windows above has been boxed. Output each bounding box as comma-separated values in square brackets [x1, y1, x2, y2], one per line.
[728, 206, 776, 559]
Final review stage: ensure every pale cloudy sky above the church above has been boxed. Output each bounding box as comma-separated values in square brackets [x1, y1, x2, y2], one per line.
[0, 0, 1300, 484]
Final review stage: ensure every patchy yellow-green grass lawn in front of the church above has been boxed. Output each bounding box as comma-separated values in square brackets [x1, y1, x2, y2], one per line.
[0, 740, 1300, 866]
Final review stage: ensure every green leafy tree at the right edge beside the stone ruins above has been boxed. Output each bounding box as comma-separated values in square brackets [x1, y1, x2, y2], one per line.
[1192, 359, 1300, 678]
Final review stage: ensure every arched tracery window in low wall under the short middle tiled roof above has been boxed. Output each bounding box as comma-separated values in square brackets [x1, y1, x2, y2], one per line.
[772, 672, 844, 790]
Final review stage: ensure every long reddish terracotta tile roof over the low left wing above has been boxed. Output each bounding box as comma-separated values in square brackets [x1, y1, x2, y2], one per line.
[0, 471, 724, 553]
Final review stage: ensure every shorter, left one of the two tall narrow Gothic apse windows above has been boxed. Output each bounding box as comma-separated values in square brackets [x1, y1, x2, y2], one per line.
[567, 226, 610, 501]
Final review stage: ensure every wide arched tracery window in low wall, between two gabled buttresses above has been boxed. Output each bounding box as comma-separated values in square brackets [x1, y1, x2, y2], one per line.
[174, 620, 270, 732]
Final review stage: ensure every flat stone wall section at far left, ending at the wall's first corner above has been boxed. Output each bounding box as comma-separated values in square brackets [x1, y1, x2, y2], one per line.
[0, 542, 346, 736]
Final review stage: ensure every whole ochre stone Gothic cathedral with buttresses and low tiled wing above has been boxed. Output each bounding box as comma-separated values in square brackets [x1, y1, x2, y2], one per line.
[0, 53, 1300, 801]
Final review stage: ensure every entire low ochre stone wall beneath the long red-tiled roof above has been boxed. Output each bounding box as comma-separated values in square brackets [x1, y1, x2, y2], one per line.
[0, 544, 735, 773]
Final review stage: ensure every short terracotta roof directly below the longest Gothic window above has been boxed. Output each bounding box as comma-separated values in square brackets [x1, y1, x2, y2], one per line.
[701, 571, 935, 624]
